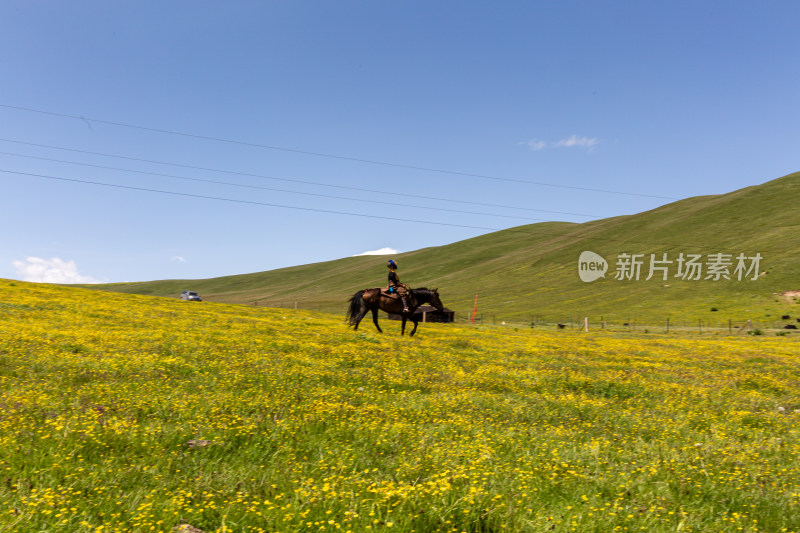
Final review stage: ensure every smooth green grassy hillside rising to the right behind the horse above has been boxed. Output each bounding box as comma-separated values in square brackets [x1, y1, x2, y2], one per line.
[91, 173, 800, 324]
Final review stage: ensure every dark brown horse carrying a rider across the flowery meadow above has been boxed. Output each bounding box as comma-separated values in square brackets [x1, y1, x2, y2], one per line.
[347, 287, 444, 337]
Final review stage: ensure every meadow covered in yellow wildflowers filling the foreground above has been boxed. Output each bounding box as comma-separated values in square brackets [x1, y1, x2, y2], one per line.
[0, 280, 800, 533]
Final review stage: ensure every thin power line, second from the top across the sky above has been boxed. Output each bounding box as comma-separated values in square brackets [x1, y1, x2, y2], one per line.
[0, 138, 599, 218]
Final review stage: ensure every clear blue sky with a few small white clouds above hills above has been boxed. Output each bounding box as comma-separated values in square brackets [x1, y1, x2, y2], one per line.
[0, 0, 800, 282]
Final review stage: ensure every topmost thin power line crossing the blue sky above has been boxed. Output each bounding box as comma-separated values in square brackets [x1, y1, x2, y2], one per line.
[0, 104, 679, 200]
